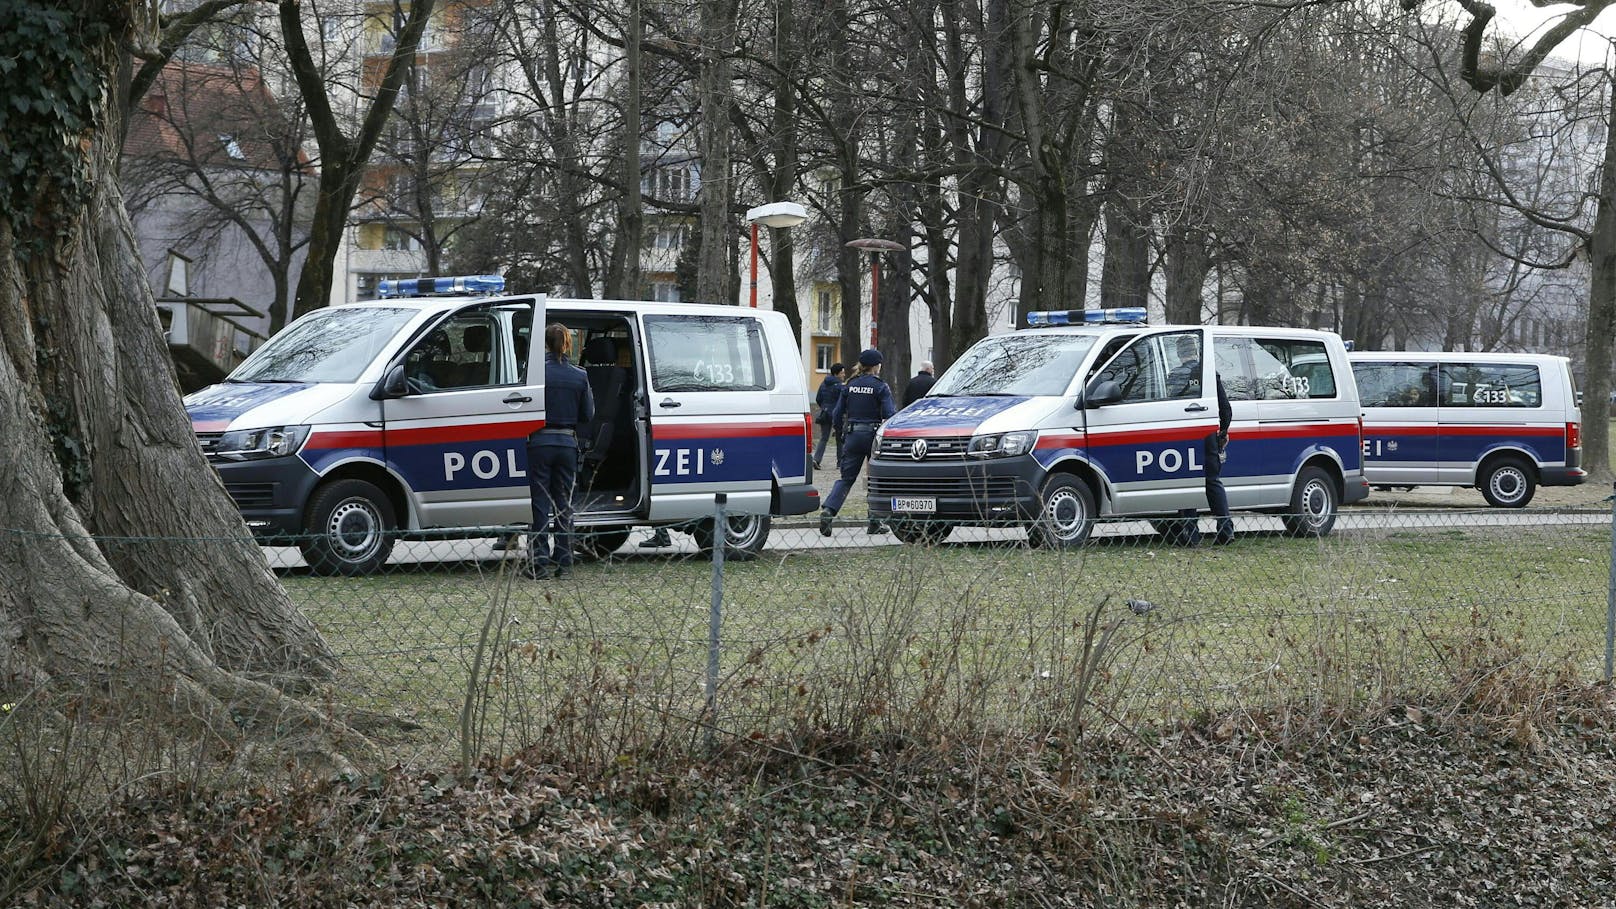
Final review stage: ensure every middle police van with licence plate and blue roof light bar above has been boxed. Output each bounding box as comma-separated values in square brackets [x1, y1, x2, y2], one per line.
[868, 309, 1369, 547]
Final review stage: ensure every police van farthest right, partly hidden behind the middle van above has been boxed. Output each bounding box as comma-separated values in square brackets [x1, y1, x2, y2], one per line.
[1348, 351, 1589, 508]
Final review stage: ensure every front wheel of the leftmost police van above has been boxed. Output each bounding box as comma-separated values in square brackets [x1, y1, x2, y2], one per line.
[297, 480, 398, 576]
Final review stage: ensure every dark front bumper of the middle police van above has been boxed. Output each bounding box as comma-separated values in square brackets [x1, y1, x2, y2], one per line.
[868, 455, 1049, 524]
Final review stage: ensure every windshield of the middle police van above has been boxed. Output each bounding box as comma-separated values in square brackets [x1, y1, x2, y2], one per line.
[926, 328, 1094, 398]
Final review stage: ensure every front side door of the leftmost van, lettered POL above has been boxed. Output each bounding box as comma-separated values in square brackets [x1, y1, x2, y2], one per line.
[381, 296, 545, 529]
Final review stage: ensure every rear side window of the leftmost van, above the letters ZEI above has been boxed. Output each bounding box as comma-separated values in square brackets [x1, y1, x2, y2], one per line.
[645, 315, 774, 391]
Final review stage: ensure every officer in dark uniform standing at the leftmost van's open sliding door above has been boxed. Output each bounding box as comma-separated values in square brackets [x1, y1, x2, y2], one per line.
[527, 322, 595, 577]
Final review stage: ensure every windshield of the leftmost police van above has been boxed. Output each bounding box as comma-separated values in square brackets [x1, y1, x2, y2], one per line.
[226, 306, 417, 383]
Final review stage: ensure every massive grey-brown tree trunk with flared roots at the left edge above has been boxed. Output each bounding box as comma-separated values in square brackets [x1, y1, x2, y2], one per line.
[0, 5, 336, 701]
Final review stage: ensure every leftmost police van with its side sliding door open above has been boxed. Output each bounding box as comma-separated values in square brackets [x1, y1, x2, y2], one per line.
[186, 277, 819, 574]
